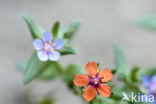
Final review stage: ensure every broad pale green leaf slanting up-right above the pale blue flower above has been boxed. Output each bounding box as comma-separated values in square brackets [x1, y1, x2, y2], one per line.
[58, 19, 81, 42]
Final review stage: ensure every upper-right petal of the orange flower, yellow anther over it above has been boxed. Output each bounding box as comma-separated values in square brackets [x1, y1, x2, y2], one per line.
[99, 68, 114, 82]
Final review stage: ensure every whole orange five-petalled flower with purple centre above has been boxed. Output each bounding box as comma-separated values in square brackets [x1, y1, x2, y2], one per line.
[73, 62, 113, 101]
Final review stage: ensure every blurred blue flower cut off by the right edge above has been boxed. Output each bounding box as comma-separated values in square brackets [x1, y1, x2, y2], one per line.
[142, 75, 156, 104]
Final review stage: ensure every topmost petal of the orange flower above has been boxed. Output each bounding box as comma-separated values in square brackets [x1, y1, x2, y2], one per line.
[85, 62, 98, 76]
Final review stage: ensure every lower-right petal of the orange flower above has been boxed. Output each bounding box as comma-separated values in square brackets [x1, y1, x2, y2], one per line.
[97, 84, 111, 97]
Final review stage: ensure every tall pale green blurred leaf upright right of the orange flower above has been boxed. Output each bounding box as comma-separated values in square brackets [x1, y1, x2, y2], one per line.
[114, 45, 131, 81]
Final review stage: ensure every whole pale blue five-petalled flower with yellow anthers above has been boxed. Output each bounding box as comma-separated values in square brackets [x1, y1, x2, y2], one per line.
[33, 31, 64, 61]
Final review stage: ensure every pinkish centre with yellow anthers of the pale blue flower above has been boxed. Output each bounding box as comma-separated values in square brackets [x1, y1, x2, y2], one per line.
[43, 41, 55, 52]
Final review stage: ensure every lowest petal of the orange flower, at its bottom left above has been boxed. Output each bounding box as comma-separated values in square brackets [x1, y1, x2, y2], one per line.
[83, 85, 96, 101]
